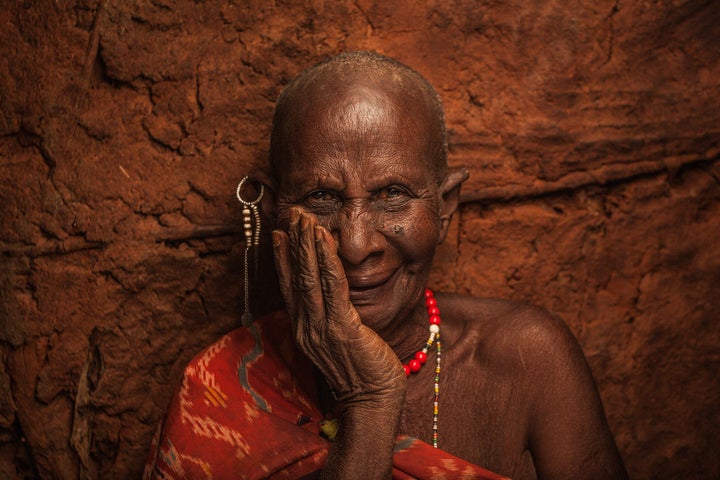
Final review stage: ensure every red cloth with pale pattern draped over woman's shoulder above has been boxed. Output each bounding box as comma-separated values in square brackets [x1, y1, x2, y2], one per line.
[143, 311, 505, 480]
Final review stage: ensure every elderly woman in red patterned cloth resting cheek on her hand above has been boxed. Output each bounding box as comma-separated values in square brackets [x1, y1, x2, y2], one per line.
[146, 52, 626, 479]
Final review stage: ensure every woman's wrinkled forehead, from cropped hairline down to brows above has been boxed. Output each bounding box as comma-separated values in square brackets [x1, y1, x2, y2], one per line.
[274, 73, 444, 186]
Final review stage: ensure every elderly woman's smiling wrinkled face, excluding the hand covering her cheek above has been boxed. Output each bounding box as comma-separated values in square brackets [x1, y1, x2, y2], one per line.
[277, 79, 441, 335]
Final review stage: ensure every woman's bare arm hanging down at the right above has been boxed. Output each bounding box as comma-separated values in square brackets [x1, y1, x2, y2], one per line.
[519, 310, 627, 480]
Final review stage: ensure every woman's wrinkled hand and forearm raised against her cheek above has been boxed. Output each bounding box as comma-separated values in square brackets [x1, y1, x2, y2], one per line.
[273, 207, 407, 479]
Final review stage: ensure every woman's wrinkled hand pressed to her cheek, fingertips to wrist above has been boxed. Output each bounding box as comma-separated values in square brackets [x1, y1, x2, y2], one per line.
[273, 207, 407, 404]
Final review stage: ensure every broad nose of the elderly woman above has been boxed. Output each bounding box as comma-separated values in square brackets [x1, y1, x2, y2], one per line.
[333, 209, 383, 265]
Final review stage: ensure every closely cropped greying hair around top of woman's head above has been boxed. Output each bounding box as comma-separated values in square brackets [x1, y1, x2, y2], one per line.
[270, 51, 447, 183]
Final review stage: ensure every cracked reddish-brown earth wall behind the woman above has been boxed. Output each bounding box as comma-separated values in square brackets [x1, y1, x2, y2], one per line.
[0, 0, 720, 479]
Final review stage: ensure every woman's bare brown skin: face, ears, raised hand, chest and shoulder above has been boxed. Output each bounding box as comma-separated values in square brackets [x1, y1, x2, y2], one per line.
[266, 71, 625, 479]
